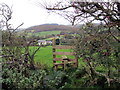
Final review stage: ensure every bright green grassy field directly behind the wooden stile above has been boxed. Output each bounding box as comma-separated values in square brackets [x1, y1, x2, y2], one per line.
[31, 46, 83, 67]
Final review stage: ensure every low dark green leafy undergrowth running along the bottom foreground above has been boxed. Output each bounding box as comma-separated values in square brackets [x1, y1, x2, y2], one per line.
[2, 62, 120, 90]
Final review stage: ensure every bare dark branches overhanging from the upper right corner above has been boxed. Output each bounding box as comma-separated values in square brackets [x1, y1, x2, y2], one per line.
[43, 0, 120, 42]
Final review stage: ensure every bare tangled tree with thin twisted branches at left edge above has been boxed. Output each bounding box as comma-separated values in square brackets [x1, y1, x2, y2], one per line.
[0, 4, 40, 69]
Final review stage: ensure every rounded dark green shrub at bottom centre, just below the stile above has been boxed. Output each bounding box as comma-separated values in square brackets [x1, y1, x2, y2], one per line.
[44, 71, 69, 89]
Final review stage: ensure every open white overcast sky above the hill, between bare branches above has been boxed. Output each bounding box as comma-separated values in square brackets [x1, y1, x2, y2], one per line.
[0, 0, 70, 28]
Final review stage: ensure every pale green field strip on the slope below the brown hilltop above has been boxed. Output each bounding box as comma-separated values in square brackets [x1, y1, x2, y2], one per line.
[28, 31, 61, 37]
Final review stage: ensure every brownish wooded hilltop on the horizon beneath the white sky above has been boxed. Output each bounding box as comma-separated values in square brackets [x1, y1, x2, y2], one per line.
[26, 24, 79, 33]
